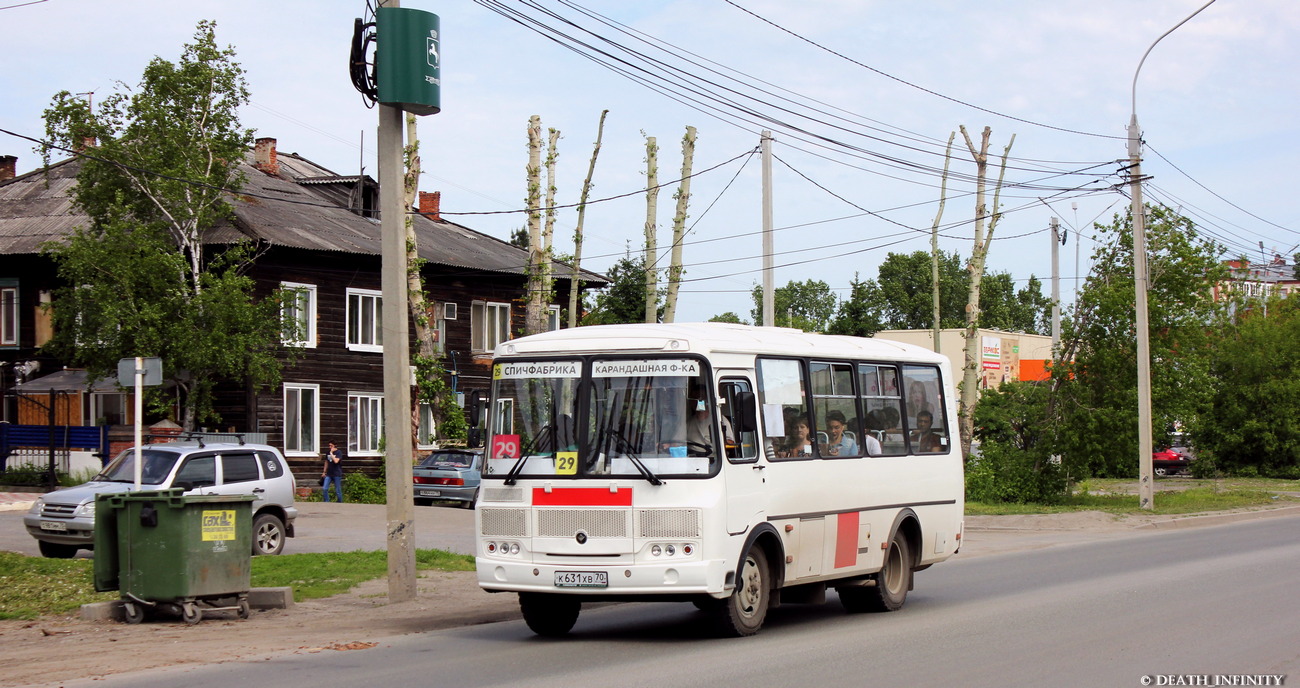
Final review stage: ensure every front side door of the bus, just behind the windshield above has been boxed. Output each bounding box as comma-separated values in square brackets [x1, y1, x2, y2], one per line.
[718, 373, 767, 535]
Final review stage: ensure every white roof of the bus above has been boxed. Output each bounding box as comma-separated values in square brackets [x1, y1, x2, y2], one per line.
[495, 323, 948, 364]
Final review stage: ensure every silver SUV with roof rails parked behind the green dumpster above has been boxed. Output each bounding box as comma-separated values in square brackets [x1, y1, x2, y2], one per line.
[22, 441, 298, 559]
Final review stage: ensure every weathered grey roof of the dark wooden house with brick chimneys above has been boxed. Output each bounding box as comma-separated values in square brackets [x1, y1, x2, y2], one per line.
[0, 146, 608, 286]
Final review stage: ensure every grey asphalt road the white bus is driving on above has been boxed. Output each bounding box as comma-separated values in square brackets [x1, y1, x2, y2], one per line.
[48, 516, 1300, 688]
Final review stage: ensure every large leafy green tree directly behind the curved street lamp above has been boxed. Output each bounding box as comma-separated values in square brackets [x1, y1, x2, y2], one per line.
[1052, 208, 1225, 477]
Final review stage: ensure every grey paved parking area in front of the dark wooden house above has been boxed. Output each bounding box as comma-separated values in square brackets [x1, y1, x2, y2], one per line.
[0, 502, 475, 558]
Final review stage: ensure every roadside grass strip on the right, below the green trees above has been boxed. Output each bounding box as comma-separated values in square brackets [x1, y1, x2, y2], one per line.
[966, 479, 1300, 515]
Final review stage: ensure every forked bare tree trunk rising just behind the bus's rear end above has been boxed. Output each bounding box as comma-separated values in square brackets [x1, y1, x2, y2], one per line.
[958, 126, 1015, 455]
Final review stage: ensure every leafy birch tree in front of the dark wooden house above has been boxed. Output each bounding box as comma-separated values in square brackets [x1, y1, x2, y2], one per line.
[42, 21, 291, 429]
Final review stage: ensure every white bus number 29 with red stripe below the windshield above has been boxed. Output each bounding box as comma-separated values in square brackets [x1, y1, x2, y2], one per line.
[471, 323, 965, 636]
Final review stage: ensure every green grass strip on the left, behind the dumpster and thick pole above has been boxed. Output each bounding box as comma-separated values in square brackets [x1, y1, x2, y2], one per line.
[0, 549, 475, 619]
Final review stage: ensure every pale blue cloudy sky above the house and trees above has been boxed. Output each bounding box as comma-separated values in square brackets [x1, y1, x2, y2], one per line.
[0, 0, 1300, 321]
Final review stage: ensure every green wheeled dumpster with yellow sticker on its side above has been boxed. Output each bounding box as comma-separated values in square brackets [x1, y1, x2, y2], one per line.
[95, 489, 254, 624]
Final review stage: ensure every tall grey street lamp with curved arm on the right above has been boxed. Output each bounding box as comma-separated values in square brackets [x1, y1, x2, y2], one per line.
[1128, 0, 1214, 509]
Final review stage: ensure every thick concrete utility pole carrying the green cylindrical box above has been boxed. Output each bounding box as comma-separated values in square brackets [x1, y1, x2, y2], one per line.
[376, 0, 415, 602]
